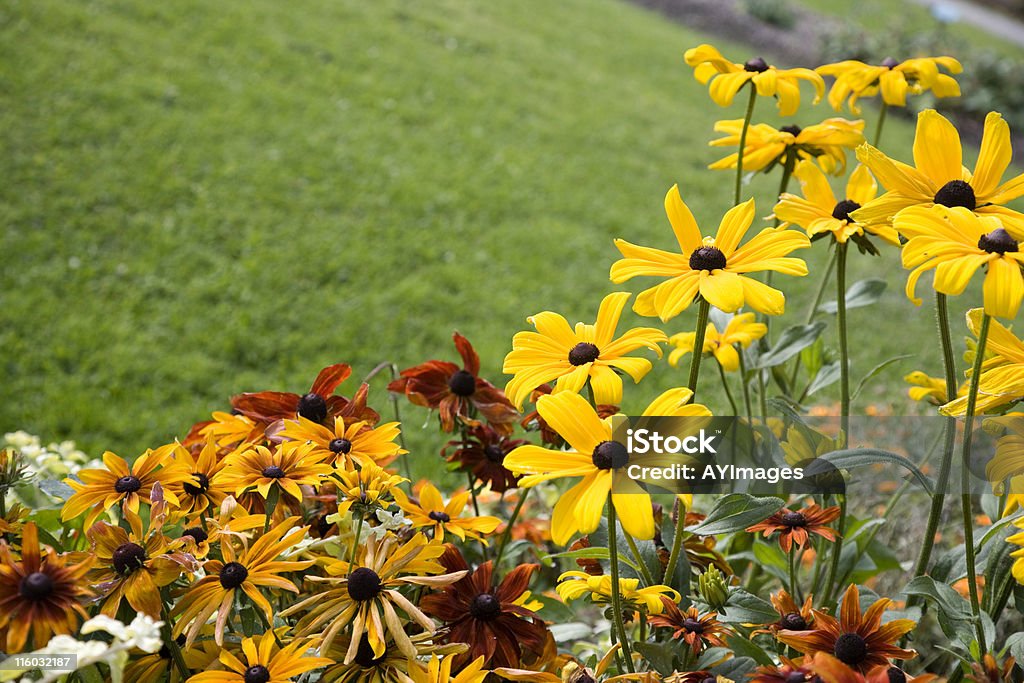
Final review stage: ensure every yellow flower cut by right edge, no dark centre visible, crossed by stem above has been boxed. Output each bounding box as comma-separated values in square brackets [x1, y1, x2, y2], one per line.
[939, 308, 1024, 417]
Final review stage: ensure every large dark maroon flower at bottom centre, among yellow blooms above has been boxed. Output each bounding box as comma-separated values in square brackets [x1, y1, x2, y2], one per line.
[420, 546, 547, 670]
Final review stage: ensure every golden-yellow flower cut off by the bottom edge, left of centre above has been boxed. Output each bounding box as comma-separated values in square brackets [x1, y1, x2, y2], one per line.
[182, 631, 334, 683]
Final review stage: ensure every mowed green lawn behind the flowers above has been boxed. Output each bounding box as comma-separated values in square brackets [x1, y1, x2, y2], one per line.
[0, 0, 1015, 475]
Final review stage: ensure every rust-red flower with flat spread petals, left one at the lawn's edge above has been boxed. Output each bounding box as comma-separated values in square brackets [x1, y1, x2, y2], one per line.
[231, 362, 380, 425]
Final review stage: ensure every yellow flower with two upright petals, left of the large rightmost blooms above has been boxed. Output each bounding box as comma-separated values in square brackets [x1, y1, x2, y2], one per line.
[775, 161, 900, 248]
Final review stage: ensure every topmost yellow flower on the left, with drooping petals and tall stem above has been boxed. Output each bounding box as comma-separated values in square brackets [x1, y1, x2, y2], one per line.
[685, 44, 825, 116]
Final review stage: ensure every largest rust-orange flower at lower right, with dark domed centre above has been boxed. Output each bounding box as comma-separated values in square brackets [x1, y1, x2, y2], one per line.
[776, 585, 918, 674]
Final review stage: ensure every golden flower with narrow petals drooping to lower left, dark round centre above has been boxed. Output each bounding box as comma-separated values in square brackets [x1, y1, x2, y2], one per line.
[171, 517, 313, 645]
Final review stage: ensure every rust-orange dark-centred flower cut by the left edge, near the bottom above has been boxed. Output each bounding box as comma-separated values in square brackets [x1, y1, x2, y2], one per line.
[0, 522, 95, 653]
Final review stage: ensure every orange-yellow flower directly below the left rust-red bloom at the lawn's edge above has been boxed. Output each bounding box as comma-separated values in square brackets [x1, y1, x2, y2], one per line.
[278, 416, 408, 470]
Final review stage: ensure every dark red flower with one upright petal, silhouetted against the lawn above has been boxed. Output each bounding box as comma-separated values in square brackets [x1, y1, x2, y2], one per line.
[387, 332, 519, 434]
